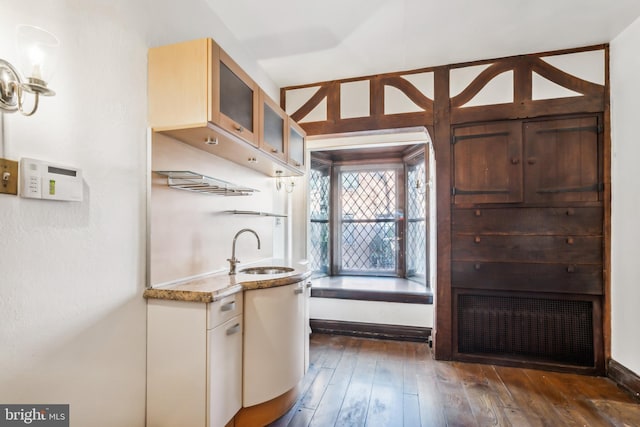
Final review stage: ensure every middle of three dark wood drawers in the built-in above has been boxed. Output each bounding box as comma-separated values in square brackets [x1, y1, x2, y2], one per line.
[451, 234, 602, 264]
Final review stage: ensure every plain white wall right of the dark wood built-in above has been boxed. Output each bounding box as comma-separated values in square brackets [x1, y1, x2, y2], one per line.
[610, 15, 640, 375]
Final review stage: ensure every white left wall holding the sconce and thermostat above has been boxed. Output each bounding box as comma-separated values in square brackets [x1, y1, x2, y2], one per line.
[0, 0, 274, 426]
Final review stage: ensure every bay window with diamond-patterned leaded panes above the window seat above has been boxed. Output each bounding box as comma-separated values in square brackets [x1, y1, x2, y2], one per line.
[308, 144, 435, 289]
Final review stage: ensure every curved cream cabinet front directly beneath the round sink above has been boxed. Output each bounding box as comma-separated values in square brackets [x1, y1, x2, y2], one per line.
[242, 282, 308, 407]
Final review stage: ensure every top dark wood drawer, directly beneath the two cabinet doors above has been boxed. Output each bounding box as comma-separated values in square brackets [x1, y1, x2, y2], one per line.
[451, 207, 602, 236]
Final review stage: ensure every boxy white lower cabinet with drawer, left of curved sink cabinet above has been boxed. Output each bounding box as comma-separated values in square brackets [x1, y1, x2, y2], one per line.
[147, 293, 243, 427]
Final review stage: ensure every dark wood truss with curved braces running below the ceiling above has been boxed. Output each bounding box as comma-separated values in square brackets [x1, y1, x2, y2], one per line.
[281, 45, 608, 135]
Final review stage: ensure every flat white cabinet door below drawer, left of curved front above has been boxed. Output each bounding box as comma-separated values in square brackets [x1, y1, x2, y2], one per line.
[207, 315, 243, 427]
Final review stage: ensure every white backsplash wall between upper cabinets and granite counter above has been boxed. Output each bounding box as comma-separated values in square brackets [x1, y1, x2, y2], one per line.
[149, 135, 287, 286]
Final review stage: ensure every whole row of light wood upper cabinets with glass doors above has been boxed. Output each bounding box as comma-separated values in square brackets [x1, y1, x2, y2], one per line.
[148, 39, 303, 176]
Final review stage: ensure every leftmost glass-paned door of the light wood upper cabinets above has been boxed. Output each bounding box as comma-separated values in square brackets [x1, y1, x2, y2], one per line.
[213, 49, 259, 146]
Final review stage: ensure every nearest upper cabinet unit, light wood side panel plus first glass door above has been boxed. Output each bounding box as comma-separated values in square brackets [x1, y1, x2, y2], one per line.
[149, 39, 259, 145]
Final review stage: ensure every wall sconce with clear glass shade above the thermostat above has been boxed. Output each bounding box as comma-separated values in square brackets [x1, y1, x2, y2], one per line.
[0, 25, 60, 116]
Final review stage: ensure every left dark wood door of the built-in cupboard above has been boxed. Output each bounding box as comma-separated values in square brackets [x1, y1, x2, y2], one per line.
[452, 122, 522, 203]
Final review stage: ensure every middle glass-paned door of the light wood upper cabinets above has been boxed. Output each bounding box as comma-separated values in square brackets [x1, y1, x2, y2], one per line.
[260, 92, 288, 161]
